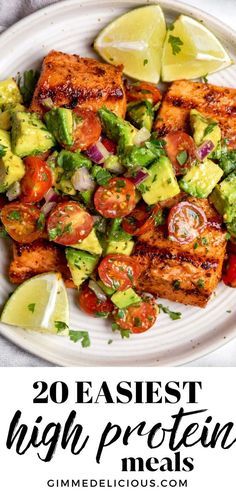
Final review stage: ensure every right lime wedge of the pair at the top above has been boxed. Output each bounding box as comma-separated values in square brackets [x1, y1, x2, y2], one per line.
[162, 15, 232, 81]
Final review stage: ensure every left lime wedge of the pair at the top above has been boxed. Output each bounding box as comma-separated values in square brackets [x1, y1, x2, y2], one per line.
[94, 5, 166, 83]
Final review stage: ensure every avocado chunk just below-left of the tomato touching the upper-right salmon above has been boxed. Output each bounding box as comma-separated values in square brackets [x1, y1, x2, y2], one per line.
[138, 156, 180, 205]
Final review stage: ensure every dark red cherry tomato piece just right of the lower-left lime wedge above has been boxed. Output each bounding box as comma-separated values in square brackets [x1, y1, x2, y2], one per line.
[78, 285, 114, 317]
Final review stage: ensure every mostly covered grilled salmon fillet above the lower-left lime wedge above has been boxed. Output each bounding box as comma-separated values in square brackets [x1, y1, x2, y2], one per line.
[9, 239, 74, 287]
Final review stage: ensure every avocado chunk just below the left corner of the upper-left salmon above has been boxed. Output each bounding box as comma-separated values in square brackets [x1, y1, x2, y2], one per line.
[12, 112, 55, 158]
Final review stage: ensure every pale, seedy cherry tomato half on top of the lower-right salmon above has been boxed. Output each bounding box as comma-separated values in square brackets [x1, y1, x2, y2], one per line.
[168, 201, 207, 244]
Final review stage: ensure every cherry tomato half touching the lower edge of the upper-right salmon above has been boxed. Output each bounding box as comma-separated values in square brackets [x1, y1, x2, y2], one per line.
[164, 131, 196, 175]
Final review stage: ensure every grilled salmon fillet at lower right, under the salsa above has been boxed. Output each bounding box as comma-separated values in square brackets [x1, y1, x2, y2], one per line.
[133, 197, 227, 307]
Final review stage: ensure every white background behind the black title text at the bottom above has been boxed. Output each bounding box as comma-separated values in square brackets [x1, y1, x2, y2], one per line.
[0, 368, 236, 495]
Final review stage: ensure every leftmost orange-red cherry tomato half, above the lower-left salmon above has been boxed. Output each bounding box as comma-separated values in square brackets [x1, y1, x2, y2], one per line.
[1, 202, 42, 243]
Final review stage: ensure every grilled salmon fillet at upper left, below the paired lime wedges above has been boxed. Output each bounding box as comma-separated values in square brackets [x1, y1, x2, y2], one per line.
[30, 51, 126, 117]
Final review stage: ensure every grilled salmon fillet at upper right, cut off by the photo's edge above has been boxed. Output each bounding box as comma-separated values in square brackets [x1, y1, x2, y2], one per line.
[154, 80, 236, 148]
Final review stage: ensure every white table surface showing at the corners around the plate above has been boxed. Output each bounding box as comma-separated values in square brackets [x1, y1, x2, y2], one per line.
[0, 0, 236, 367]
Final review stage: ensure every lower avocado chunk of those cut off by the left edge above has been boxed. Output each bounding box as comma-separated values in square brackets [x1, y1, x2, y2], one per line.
[0, 130, 25, 193]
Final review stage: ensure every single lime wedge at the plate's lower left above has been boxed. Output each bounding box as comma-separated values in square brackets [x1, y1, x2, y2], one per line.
[1, 273, 69, 335]
